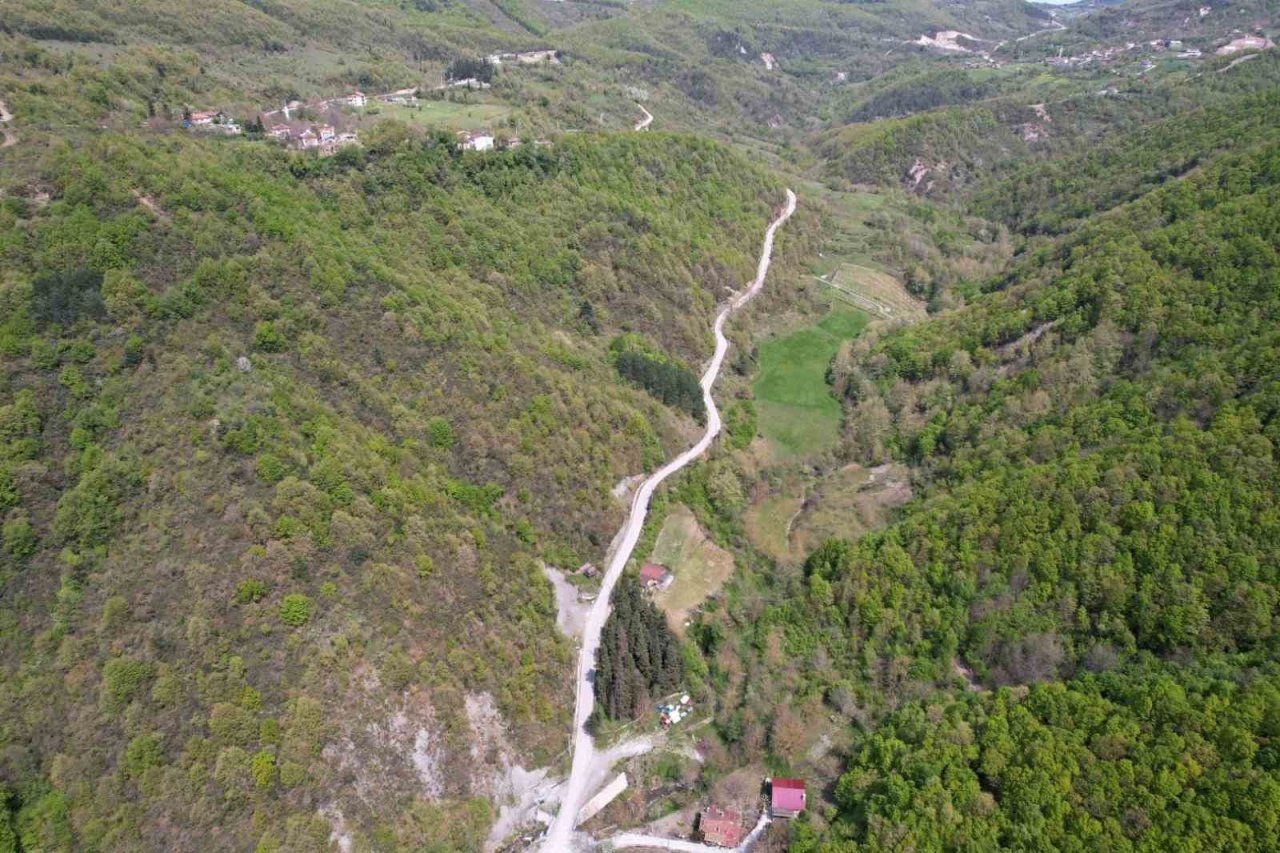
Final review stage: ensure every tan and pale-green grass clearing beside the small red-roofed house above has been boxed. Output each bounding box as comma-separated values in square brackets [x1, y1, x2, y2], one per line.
[652, 506, 733, 634]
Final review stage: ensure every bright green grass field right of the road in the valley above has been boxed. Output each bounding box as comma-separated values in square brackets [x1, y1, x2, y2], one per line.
[751, 307, 867, 457]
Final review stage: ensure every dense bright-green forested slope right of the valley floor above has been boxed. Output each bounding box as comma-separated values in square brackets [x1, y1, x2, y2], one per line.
[695, 61, 1280, 850]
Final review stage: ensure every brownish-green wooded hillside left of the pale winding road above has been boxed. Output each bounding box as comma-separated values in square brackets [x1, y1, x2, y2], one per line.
[0, 92, 798, 849]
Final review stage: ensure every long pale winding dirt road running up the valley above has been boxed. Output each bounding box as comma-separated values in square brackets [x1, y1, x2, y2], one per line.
[541, 188, 796, 853]
